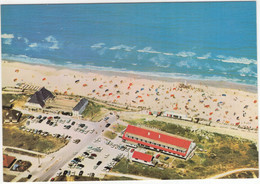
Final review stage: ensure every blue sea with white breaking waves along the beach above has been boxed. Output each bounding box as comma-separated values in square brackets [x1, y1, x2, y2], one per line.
[1, 2, 257, 85]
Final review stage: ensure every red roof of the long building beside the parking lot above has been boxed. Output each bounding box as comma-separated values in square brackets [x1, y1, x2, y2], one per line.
[123, 125, 192, 156]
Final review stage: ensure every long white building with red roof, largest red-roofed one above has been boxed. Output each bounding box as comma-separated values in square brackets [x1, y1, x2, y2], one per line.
[122, 125, 196, 159]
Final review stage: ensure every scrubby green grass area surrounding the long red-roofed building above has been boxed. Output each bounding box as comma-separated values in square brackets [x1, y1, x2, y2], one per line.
[113, 119, 258, 179]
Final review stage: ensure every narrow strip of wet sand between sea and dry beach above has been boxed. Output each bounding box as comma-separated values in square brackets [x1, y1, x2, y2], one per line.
[2, 59, 258, 94]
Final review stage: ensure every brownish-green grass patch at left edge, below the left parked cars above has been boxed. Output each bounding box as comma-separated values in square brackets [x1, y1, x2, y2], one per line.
[3, 125, 68, 153]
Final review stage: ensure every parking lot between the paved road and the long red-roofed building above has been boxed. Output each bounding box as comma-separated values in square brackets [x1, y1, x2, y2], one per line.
[53, 133, 130, 177]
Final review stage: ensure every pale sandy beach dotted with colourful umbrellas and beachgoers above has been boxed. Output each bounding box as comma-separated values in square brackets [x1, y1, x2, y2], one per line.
[2, 61, 258, 128]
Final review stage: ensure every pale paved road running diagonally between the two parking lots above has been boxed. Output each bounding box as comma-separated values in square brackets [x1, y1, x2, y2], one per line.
[30, 116, 116, 181]
